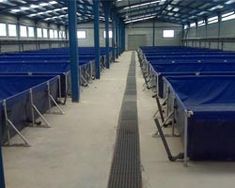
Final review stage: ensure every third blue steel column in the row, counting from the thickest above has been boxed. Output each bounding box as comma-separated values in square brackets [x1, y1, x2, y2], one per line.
[104, 1, 110, 69]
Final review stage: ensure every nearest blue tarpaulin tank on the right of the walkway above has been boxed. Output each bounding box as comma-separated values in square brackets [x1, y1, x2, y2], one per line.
[167, 76, 235, 160]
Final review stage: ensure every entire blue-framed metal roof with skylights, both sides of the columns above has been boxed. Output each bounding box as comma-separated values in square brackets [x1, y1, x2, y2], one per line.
[0, 0, 235, 25]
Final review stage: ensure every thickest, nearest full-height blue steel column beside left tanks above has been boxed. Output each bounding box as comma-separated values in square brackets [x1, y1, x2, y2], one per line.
[67, 0, 80, 102]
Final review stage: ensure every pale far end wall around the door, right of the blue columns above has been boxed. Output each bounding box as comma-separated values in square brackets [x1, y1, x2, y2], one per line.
[126, 21, 182, 48]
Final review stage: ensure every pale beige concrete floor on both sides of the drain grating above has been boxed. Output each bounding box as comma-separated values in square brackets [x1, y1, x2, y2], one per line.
[3, 52, 235, 188]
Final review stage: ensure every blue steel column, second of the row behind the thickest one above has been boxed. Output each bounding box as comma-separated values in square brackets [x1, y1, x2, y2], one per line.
[93, 0, 100, 79]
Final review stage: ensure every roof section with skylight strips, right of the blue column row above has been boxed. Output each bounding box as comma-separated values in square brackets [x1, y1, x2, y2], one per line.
[115, 0, 235, 24]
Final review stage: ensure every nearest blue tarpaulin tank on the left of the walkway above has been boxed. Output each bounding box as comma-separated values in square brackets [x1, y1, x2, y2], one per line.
[0, 76, 59, 142]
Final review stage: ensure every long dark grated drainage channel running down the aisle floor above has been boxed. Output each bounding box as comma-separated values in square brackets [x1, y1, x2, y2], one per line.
[108, 52, 142, 188]
